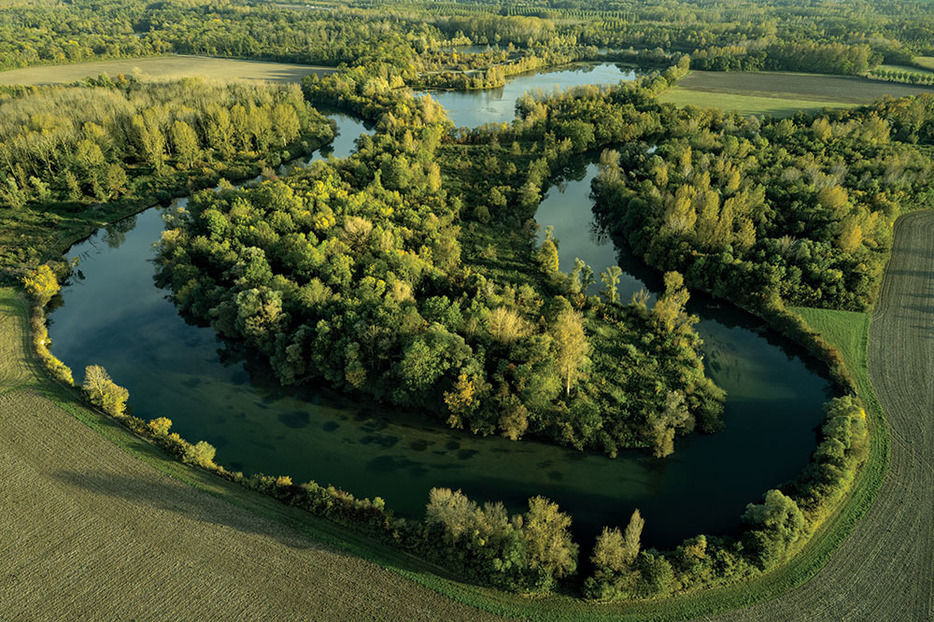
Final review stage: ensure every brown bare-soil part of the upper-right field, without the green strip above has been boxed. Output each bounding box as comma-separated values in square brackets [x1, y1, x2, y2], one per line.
[672, 71, 934, 104]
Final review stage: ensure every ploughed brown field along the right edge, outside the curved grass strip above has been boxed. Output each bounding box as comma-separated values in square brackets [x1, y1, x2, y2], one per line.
[716, 212, 934, 622]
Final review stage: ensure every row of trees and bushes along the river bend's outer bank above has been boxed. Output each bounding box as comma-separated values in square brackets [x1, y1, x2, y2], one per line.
[42, 344, 869, 601]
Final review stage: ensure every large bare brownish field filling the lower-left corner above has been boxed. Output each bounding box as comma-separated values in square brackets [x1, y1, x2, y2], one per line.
[0, 290, 504, 622]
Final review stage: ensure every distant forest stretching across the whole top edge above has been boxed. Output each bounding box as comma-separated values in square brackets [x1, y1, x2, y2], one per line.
[0, 0, 934, 77]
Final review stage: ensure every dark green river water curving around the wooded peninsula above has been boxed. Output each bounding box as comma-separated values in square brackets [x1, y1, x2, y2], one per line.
[50, 83, 829, 546]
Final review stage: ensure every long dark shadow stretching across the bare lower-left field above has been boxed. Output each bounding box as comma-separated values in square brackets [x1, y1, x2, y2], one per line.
[53, 470, 346, 556]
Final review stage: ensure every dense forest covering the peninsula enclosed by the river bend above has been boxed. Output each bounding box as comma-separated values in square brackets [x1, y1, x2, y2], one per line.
[154, 78, 722, 456]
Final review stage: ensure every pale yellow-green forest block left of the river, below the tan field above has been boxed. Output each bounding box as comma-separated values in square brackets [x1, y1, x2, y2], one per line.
[0, 76, 333, 267]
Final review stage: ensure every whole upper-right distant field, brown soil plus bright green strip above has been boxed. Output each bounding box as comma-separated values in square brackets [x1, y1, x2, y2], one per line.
[660, 71, 934, 116]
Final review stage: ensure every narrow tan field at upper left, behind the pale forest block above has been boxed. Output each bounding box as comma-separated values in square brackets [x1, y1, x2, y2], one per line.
[0, 55, 334, 85]
